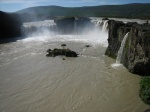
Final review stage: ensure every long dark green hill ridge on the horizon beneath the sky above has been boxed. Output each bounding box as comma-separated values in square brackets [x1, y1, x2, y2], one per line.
[13, 3, 150, 19]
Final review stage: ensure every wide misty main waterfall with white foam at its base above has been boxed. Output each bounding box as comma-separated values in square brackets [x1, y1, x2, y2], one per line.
[23, 20, 108, 47]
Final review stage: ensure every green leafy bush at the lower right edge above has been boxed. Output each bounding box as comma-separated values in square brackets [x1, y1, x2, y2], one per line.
[140, 76, 150, 105]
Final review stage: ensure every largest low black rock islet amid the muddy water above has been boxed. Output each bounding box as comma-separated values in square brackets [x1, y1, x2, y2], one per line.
[46, 48, 78, 57]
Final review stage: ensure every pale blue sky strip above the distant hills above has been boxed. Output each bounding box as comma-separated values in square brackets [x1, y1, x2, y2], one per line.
[0, 0, 150, 12]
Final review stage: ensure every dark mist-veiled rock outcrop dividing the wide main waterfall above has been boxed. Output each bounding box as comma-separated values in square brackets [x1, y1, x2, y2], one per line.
[55, 17, 94, 34]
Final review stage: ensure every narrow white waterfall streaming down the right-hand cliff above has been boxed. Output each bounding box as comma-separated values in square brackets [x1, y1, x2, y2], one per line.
[116, 32, 129, 64]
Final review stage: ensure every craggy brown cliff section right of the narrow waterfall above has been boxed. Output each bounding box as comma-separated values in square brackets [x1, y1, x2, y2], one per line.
[123, 24, 150, 75]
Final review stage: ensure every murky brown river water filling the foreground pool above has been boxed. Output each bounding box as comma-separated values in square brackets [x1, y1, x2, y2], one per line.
[0, 36, 148, 112]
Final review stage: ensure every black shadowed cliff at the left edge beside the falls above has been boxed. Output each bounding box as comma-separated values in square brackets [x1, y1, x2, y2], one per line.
[0, 11, 22, 38]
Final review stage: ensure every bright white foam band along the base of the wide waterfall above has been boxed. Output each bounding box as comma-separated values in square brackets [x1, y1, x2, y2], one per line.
[22, 31, 108, 47]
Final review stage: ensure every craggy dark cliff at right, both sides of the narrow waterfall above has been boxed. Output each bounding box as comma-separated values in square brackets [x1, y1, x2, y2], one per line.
[105, 20, 150, 75]
